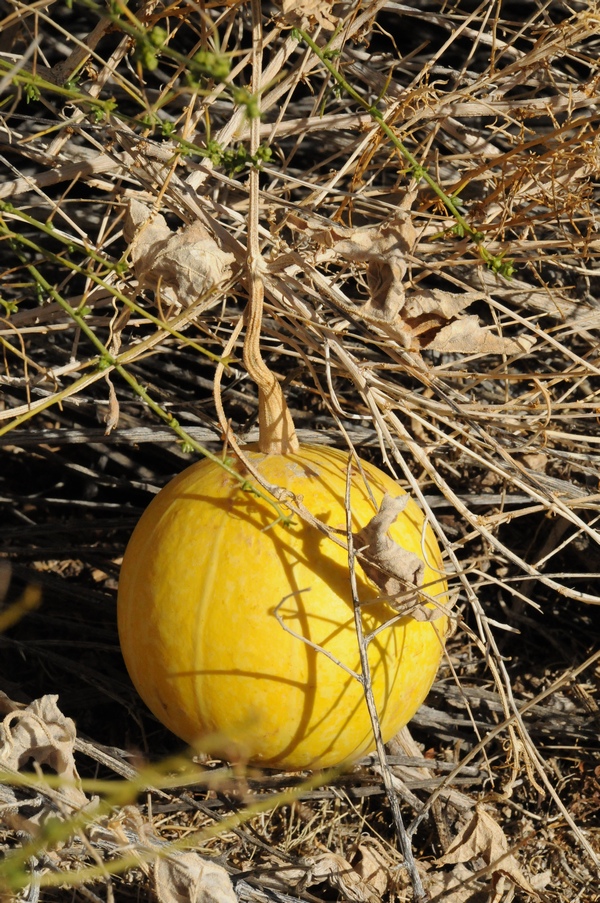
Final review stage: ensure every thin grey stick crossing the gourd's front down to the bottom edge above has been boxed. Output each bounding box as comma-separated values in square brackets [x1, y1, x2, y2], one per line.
[345, 466, 427, 901]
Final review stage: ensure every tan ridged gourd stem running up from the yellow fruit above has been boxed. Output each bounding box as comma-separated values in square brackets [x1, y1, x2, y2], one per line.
[243, 0, 299, 455]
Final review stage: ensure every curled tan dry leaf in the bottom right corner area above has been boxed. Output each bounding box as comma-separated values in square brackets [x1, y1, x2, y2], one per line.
[438, 806, 539, 901]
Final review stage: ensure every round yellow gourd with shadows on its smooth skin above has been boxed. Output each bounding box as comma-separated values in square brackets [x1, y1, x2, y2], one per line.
[118, 446, 447, 770]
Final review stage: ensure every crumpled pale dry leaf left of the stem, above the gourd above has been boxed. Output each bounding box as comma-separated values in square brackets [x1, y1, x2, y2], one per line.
[124, 199, 234, 307]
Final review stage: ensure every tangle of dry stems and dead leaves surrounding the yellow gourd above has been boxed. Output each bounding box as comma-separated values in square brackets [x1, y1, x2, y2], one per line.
[0, 0, 600, 903]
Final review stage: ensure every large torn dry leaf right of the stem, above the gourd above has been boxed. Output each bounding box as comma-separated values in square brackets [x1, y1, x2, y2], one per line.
[289, 211, 534, 354]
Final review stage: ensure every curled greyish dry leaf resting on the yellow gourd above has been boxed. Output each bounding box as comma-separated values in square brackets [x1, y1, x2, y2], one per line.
[354, 493, 443, 621]
